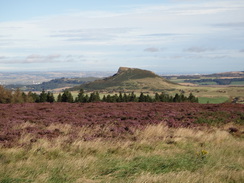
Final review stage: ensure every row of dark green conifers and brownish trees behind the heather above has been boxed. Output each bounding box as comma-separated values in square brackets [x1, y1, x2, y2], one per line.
[0, 86, 198, 103]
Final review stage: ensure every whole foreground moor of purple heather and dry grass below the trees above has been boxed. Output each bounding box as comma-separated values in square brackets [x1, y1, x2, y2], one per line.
[0, 103, 244, 183]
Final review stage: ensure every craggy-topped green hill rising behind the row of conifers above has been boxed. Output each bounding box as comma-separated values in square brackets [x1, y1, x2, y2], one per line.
[71, 67, 177, 91]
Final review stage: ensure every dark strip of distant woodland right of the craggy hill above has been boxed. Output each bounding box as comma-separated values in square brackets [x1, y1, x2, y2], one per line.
[184, 78, 244, 85]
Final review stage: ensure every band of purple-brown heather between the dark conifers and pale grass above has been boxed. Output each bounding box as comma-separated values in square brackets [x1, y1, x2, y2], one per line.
[0, 102, 244, 146]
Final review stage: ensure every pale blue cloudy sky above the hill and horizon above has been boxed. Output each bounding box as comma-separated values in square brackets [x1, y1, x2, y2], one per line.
[0, 0, 244, 74]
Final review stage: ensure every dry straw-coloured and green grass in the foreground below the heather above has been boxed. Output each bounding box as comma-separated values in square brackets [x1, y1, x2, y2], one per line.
[0, 124, 244, 183]
